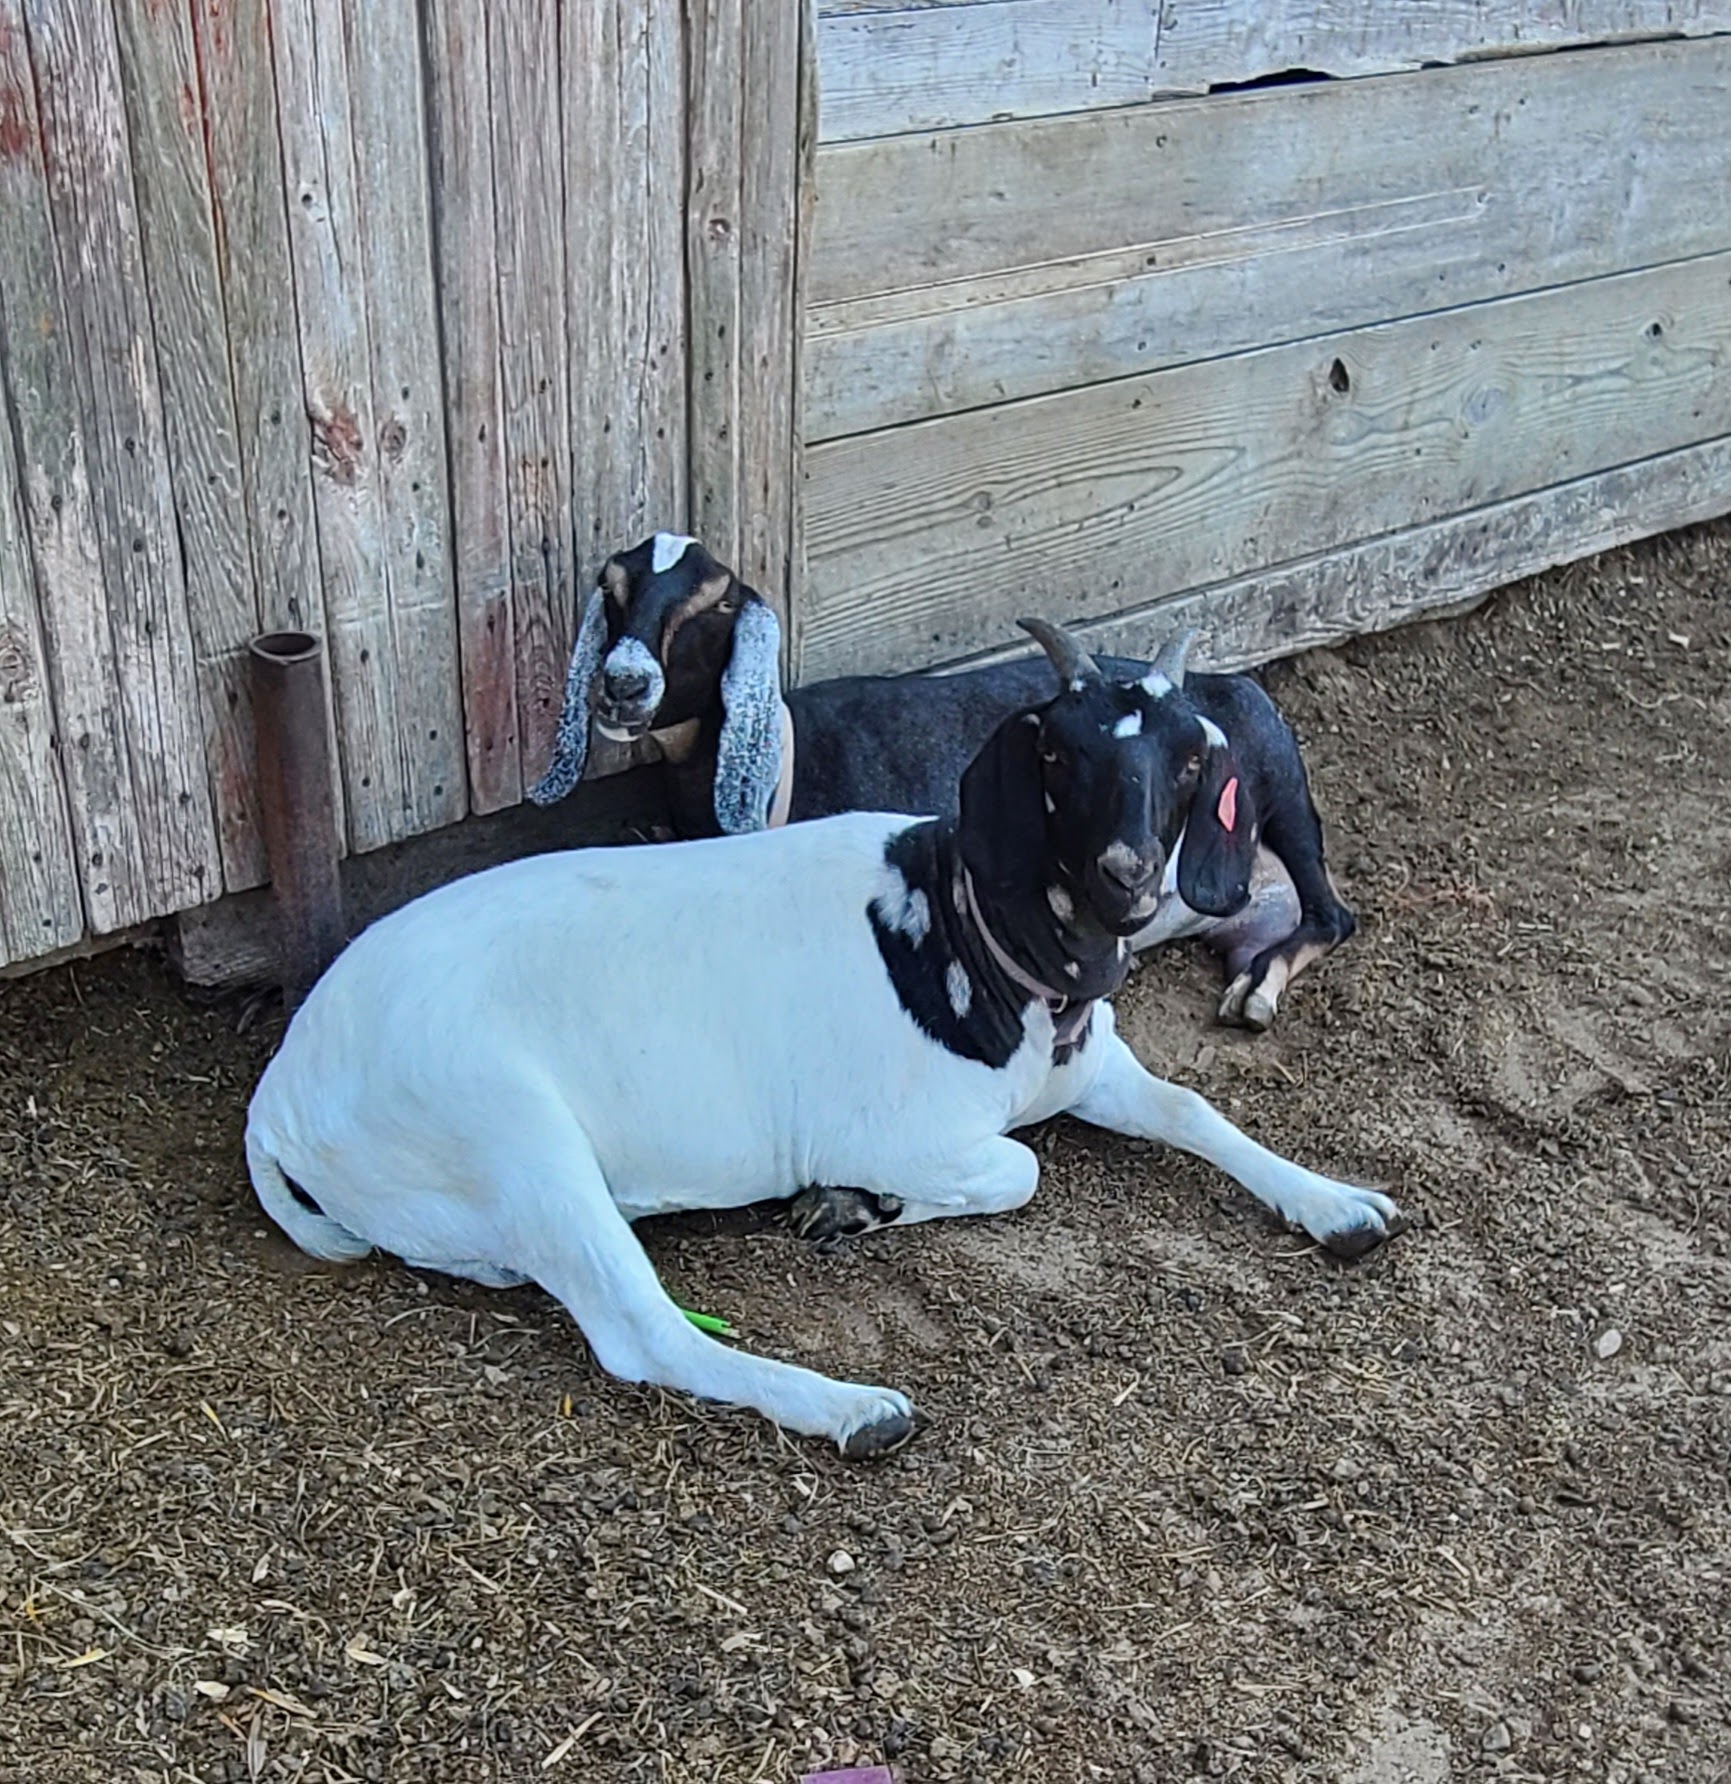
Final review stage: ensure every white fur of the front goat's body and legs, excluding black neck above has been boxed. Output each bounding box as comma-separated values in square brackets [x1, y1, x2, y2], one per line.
[246, 814, 1396, 1447]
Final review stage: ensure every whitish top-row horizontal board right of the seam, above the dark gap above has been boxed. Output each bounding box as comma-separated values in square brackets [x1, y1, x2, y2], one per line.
[1155, 0, 1731, 93]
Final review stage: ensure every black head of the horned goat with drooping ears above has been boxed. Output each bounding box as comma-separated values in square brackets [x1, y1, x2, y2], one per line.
[962, 619, 1256, 937]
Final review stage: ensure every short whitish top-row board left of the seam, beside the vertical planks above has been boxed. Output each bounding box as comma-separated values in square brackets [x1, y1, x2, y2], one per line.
[817, 0, 1160, 143]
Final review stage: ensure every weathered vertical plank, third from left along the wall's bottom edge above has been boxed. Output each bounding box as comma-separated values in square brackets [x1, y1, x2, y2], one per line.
[23, 0, 219, 919]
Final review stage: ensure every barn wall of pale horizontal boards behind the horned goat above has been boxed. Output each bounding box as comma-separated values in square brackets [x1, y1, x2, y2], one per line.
[798, 13, 1731, 678]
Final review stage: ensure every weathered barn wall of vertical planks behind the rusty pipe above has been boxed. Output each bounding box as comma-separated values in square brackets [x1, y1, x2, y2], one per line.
[0, 0, 808, 963]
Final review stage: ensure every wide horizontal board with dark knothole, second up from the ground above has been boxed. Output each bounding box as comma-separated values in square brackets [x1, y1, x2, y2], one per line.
[799, 255, 1731, 678]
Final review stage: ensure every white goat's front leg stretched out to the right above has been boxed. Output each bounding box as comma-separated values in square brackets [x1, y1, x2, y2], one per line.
[1069, 1035, 1404, 1258]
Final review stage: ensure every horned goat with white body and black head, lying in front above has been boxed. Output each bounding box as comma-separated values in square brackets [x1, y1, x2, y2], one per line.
[246, 623, 1397, 1456]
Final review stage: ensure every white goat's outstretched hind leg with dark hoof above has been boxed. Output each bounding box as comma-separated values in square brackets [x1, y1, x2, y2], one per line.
[496, 1117, 914, 1458]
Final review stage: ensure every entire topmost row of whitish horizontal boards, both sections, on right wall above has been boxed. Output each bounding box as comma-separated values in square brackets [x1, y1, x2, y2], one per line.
[817, 0, 1731, 143]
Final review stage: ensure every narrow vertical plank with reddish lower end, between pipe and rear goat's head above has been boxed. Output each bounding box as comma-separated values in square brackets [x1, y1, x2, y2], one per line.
[427, 0, 517, 812]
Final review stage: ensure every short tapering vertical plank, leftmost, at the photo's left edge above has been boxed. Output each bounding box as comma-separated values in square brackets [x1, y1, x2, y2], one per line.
[0, 363, 84, 965]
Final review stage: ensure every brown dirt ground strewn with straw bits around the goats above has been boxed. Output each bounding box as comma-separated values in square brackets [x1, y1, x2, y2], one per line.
[0, 526, 1731, 1784]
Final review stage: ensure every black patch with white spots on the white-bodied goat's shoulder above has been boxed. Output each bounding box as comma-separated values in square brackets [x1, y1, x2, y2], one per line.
[866, 822, 1031, 1070]
